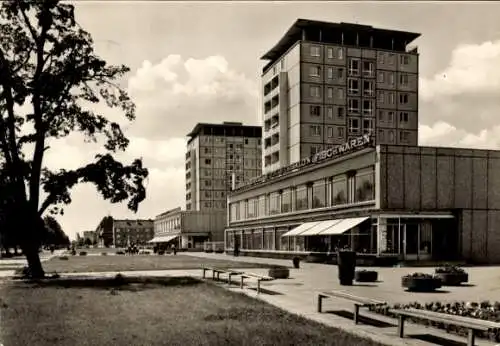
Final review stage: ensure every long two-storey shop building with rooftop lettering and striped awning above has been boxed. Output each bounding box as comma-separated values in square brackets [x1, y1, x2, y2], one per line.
[225, 135, 500, 263]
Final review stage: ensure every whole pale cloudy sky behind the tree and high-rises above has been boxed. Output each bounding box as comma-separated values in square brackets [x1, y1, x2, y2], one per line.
[37, 1, 500, 238]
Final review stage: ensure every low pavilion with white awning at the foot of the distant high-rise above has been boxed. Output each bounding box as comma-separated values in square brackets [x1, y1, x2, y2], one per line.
[151, 207, 227, 249]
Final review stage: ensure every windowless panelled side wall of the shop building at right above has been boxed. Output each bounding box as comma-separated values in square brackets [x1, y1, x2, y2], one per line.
[379, 146, 500, 263]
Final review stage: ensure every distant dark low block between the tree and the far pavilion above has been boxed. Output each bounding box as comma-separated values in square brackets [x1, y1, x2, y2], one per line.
[96, 216, 154, 248]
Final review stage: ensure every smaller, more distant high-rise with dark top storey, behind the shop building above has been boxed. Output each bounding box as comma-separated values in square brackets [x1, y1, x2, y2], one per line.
[186, 122, 262, 211]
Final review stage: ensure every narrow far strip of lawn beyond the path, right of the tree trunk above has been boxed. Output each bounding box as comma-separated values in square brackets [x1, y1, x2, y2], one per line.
[39, 254, 269, 273]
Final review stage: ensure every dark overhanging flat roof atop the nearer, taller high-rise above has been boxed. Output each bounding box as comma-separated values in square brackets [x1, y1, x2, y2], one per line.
[261, 18, 421, 60]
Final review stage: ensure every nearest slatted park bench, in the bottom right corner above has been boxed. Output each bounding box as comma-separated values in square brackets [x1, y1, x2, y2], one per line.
[390, 309, 500, 346]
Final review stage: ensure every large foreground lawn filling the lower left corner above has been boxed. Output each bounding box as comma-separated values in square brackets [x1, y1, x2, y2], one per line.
[0, 278, 380, 346]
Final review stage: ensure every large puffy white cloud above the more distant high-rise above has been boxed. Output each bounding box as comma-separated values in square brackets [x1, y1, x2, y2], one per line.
[128, 55, 258, 139]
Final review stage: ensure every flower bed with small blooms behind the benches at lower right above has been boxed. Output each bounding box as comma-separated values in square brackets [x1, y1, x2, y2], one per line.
[370, 301, 500, 342]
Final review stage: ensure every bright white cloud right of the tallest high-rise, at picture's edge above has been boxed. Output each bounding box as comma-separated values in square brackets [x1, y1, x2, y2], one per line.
[419, 40, 500, 134]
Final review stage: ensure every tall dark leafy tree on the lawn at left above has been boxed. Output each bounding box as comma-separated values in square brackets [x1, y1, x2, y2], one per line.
[0, 0, 148, 278]
